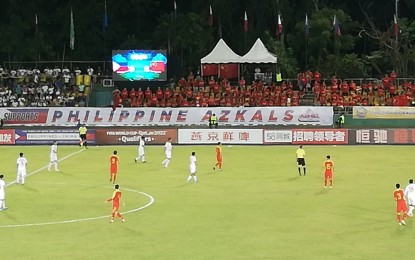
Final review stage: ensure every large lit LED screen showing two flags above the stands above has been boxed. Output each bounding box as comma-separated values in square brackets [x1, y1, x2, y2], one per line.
[112, 50, 167, 81]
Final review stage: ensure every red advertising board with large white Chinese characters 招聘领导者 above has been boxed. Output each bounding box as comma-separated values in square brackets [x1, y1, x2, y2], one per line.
[292, 129, 348, 144]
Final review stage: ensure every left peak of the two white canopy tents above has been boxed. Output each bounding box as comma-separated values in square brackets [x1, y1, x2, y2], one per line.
[200, 39, 241, 64]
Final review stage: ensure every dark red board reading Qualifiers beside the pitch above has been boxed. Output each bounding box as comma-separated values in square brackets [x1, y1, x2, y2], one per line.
[96, 128, 177, 145]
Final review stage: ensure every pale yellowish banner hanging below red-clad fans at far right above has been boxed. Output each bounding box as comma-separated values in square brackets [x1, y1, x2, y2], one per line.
[353, 106, 415, 119]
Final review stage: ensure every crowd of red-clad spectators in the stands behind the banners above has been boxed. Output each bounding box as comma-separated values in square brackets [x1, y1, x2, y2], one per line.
[113, 71, 415, 107]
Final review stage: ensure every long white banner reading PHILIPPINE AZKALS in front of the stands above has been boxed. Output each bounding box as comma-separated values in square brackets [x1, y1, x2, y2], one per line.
[0, 107, 333, 126]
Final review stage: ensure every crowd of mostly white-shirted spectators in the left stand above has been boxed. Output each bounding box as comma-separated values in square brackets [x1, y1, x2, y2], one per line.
[0, 67, 94, 107]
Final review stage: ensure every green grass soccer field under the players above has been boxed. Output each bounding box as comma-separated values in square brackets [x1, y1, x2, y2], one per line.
[0, 145, 415, 260]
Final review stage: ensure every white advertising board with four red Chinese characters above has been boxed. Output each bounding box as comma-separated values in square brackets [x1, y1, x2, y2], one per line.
[178, 129, 262, 144]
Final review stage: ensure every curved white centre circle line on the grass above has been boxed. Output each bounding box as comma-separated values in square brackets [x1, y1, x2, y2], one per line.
[0, 183, 155, 228]
